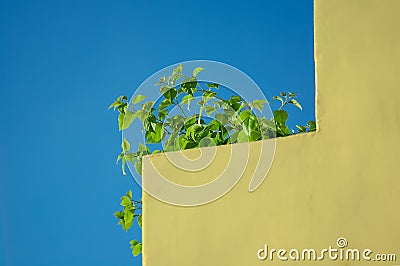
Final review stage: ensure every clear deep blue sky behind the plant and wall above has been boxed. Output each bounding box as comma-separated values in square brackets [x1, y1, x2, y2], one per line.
[0, 0, 314, 266]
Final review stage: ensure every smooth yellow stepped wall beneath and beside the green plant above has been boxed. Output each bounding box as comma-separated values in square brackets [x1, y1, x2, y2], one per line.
[143, 0, 400, 266]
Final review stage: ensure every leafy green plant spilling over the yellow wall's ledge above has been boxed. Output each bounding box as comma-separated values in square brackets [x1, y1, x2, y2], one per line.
[110, 65, 316, 256]
